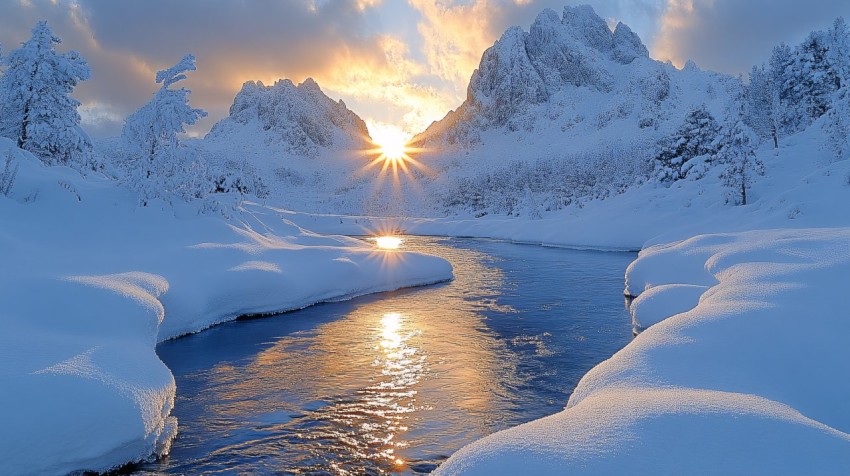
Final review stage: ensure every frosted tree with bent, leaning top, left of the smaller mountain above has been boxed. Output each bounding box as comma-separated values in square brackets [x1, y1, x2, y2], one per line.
[122, 55, 207, 205]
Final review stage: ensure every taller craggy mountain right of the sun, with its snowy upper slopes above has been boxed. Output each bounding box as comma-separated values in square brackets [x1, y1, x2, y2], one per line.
[415, 5, 739, 148]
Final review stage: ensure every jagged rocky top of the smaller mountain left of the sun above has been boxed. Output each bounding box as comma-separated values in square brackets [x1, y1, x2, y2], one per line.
[208, 79, 369, 154]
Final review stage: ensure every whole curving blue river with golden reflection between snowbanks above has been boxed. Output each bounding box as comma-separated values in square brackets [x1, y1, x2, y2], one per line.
[136, 237, 635, 474]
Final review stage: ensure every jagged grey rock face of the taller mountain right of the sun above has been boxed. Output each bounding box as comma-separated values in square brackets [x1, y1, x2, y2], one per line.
[420, 5, 649, 143]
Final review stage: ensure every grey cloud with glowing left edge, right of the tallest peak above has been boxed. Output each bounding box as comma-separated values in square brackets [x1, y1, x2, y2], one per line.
[651, 0, 850, 74]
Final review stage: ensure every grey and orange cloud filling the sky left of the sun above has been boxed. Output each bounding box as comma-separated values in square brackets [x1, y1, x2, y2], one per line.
[0, 0, 396, 138]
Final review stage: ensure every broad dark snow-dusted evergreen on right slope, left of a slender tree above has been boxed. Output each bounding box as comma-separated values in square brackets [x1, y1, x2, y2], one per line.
[655, 105, 720, 182]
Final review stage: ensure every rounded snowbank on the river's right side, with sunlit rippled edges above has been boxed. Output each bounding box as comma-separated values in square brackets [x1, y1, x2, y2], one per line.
[437, 228, 850, 474]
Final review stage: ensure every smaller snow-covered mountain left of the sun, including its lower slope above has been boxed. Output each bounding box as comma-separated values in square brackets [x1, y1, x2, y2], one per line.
[191, 79, 386, 211]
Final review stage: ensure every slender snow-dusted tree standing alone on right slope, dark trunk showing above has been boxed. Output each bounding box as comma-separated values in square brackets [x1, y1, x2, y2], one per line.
[716, 97, 764, 205]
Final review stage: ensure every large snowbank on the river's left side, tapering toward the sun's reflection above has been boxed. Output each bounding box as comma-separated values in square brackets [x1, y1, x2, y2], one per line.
[0, 139, 452, 474]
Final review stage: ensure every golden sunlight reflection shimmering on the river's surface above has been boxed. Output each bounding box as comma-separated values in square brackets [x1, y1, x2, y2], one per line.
[194, 239, 516, 474]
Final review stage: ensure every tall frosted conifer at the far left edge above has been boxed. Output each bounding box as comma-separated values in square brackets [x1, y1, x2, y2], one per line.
[0, 21, 91, 165]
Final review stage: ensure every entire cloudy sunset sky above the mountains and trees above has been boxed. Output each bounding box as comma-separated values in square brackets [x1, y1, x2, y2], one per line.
[0, 0, 850, 138]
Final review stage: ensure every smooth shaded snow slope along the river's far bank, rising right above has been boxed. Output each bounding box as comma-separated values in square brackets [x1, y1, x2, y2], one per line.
[288, 121, 850, 250]
